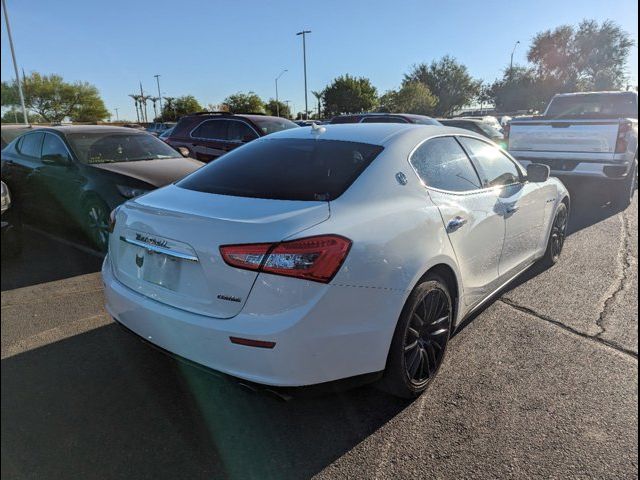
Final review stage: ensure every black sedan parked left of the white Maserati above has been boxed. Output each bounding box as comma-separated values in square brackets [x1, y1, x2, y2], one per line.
[1, 126, 202, 250]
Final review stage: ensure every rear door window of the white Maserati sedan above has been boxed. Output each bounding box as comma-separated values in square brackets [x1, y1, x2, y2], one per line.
[411, 137, 481, 192]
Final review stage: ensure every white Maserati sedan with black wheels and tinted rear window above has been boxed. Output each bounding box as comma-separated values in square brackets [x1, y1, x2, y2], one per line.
[102, 124, 569, 398]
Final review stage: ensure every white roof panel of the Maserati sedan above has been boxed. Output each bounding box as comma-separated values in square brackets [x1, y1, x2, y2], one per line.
[257, 123, 462, 145]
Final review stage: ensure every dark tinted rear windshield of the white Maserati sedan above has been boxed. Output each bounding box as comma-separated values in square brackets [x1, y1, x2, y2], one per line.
[177, 138, 383, 201]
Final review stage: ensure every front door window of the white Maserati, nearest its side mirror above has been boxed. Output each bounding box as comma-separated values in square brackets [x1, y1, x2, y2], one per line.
[460, 137, 520, 187]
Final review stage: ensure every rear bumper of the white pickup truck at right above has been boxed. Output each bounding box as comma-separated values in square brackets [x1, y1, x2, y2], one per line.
[509, 151, 635, 180]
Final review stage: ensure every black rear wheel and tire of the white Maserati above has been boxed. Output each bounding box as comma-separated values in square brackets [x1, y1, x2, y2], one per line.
[378, 274, 454, 399]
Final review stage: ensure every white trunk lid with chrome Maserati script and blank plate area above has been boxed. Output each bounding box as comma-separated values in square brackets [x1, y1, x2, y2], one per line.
[109, 185, 329, 318]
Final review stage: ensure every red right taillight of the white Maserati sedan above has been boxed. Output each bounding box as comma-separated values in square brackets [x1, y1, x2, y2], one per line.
[220, 235, 351, 283]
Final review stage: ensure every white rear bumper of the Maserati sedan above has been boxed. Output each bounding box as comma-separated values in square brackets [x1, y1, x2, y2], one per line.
[102, 256, 406, 387]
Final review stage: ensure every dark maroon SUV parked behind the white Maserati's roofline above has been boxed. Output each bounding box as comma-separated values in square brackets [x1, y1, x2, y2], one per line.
[165, 112, 298, 162]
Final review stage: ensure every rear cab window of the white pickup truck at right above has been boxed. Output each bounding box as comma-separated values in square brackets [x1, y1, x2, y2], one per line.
[546, 93, 638, 118]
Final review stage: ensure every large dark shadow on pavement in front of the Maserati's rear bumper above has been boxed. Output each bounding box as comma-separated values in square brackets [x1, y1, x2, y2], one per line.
[2, 324, 408, 479]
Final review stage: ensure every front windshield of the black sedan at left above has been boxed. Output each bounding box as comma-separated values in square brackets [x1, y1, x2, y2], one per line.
[67, 132, 179, 164]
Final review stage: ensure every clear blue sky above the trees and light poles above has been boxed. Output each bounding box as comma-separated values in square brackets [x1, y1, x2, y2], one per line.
[1, 0, 638, 119]
